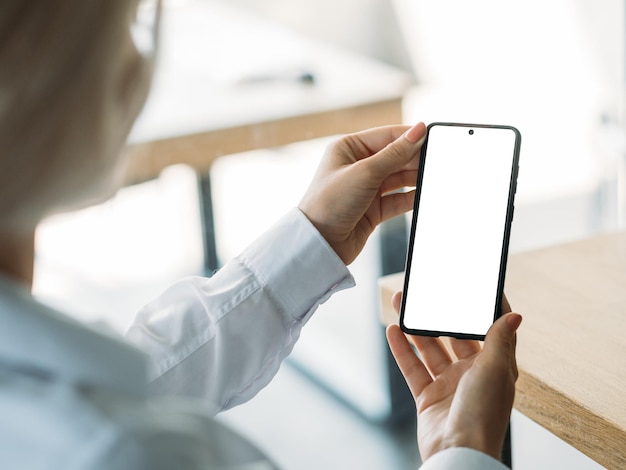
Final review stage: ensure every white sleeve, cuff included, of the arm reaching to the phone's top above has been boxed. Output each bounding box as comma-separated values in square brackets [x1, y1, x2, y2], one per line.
[126, 209, 354, 413]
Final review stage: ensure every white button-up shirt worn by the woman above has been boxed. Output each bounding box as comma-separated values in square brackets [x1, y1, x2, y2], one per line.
[0, 209, 504, 470]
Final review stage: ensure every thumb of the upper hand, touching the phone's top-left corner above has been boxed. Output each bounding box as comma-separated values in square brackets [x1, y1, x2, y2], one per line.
[367, 122, 426, 178]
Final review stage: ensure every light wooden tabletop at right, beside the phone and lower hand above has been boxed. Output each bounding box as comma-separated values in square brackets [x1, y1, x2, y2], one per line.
[380, 232, 626, 469]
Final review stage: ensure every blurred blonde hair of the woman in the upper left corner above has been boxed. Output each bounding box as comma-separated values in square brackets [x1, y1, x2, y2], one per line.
[0, 0, 150, 230]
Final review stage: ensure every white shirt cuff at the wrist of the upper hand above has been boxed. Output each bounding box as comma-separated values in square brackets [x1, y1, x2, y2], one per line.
[238, 208, 355, 317]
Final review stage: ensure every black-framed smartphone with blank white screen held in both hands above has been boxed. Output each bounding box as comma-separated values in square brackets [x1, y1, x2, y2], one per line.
[400, 122, 521, 340]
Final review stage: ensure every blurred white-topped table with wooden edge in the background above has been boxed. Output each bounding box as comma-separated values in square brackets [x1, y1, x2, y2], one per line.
[127, 0, 411, 183]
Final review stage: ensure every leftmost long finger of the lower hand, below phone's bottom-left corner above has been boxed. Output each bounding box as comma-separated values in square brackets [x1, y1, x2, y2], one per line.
[387, 325, 432, 399]
